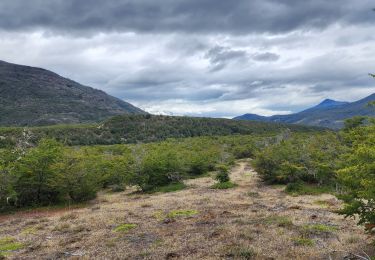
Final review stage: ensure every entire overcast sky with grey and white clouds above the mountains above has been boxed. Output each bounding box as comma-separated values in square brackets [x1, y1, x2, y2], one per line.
[0, 0, 375, 117]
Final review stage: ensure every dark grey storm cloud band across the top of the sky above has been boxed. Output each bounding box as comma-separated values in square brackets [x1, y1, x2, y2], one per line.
[0, 0, 375, 34]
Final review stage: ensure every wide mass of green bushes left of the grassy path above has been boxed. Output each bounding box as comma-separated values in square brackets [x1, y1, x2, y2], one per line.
[0, 136, 263, 209]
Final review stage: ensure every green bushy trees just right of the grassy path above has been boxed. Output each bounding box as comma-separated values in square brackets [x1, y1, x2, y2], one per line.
[254, 133, 346, 186]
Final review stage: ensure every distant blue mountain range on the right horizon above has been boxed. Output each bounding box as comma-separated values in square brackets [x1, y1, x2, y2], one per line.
[233, 94, 375, 129]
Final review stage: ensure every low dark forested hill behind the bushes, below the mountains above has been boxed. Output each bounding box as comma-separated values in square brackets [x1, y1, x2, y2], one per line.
[0, 114, 326, 148]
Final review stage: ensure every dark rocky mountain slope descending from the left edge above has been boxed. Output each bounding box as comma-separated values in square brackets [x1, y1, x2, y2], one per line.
[0, 61, 145, 126]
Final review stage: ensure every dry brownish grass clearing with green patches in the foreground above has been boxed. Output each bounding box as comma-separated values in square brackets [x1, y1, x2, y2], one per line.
[0, 161, 373, 259]
